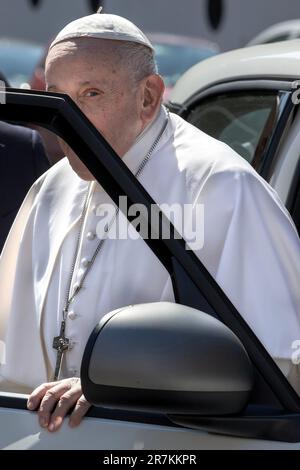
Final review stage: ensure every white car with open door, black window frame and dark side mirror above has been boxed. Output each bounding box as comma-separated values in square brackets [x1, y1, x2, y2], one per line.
[0, 41, 300, 450]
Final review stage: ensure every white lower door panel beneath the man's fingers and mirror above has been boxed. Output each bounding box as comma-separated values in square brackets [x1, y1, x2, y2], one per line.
[0, 394, 300, 450]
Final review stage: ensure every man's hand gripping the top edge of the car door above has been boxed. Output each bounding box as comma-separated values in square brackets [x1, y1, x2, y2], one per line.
[27, 377, 91, 432]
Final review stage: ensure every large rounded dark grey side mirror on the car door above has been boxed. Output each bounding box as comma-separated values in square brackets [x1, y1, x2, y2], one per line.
[81, 302, 253, 415]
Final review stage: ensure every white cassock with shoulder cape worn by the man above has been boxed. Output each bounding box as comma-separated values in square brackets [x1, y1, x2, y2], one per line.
[0, 108, 300, 388]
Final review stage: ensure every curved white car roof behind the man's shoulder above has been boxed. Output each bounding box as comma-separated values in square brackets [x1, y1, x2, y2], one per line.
[170, 39, 300, 104]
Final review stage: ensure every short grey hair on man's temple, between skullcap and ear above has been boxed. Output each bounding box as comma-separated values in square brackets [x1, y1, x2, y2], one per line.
[109, 41, 157, 84]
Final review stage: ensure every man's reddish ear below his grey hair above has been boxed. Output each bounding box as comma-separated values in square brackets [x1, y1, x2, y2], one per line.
[141, 75, 165, 124]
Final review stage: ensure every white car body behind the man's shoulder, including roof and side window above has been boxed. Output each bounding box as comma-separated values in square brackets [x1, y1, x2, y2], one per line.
[170, 40, 300, 231]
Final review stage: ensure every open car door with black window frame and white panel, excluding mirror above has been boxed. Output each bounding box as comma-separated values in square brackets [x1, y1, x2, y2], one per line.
[0, 90, 300, 450]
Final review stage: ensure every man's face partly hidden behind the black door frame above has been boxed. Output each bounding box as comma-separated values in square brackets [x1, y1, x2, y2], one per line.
[45, 38, 143, 180]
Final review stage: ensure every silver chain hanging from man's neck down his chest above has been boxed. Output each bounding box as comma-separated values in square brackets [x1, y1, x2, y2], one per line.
[63, 110, 169, 320]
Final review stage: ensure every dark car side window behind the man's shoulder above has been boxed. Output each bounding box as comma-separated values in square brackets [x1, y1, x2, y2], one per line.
[188, 92, 279, 167]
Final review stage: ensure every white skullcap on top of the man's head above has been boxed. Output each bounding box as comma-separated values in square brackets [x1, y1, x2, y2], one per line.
[50, 13, 154, 50]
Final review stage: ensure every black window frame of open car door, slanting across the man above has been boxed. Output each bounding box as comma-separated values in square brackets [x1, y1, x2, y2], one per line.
[0, 89, 300, 438]
